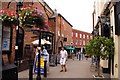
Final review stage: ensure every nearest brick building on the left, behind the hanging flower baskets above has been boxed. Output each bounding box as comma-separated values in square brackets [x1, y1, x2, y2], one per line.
[2, 2, 54, 70]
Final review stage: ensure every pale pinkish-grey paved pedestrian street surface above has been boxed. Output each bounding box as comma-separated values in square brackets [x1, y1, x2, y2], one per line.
[19, 58, 109, 78]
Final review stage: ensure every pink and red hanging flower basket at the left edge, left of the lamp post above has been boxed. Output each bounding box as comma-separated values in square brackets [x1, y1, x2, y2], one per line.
[0, 9, 17, 26]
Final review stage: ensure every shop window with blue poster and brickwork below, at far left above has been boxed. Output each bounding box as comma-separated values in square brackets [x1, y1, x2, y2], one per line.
[1, 26, 12, 64]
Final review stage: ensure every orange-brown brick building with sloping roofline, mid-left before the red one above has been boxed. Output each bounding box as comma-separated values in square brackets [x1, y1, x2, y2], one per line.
[56, 14, 73, 53]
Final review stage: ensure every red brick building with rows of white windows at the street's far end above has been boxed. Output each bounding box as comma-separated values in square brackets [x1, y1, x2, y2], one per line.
[72, 29, 92, 50]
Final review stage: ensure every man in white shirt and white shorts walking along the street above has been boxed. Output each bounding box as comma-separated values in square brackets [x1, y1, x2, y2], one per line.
[60, 47, 68, 72]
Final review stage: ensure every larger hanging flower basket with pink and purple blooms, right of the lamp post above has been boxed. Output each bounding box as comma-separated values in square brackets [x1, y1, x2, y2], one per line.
[18, 6, 45, 28]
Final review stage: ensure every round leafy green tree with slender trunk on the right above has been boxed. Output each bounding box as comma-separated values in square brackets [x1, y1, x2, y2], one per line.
[85, 36, 114, 78]
